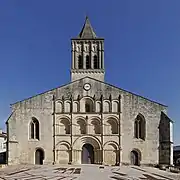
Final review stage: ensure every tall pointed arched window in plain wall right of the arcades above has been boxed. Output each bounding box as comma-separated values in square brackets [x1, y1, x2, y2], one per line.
[134, 114, 146, 140]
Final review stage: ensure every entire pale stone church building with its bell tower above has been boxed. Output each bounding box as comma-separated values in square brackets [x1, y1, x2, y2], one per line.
[6, 18, 173, 165]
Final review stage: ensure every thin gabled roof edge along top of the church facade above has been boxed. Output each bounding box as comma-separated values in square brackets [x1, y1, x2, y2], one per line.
[11, 76, 168, 107]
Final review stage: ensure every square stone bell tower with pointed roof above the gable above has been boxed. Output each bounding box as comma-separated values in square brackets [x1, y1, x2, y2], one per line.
[71, 17, 105, 81]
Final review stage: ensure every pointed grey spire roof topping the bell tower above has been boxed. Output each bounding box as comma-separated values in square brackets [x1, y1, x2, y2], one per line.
[78, 16, 97, 39]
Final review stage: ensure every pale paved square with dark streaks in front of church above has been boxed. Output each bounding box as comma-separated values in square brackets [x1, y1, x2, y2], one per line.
[0, 165, 180, 180]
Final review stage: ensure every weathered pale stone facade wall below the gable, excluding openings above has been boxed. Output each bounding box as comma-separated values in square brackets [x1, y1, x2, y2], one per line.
[8, 78, 169, 164]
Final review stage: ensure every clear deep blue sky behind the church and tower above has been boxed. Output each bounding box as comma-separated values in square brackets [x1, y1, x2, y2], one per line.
[0, 0, 180, 144]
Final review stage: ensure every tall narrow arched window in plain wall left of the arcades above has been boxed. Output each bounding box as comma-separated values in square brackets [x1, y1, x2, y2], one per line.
[30, 117, 39, 140]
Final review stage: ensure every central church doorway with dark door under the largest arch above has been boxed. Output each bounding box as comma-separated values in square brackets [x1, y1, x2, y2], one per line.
[81, 144, 94, 164]
